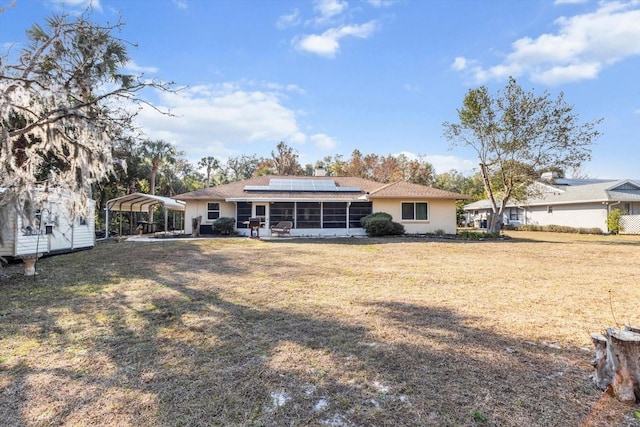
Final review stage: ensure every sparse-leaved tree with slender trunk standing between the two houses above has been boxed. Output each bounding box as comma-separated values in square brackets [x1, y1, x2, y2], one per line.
[443, 78, 601, 233]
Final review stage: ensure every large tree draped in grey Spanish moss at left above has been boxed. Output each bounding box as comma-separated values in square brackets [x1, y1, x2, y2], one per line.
[0, 12, 170, 244]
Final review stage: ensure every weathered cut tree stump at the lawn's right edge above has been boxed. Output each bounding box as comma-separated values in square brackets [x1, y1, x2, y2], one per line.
[591, 326, 640, 403]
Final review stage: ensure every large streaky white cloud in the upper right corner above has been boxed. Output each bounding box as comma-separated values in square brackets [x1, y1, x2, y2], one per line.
[451, 0, 640, 85]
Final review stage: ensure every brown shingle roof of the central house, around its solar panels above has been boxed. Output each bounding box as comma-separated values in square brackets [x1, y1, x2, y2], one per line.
[174, 175, 466, 204]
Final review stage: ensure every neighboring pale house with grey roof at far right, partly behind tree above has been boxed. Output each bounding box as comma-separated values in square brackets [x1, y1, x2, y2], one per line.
[464, 178, 640, 234]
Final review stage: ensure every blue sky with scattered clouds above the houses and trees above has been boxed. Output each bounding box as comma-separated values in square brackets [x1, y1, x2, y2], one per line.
[0, 0, 640, 179]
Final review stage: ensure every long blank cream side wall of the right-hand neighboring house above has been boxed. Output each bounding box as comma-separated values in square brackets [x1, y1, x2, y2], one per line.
[524, 203, 607, 233]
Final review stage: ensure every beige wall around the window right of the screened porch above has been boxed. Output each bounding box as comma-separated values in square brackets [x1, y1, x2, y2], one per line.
[373, 199, 456, 234]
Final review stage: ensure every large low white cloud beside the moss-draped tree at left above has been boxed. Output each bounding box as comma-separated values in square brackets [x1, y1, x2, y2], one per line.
[138, 82, 307, 159]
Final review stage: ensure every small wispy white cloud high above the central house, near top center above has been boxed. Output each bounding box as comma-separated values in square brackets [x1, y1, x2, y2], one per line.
[293, 21, 377, 58]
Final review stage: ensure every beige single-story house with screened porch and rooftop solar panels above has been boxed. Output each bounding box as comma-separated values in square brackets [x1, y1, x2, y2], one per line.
[174, 176, 466, 236]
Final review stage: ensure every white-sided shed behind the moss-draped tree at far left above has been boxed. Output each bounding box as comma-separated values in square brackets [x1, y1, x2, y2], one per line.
[0, 194, 95, 258]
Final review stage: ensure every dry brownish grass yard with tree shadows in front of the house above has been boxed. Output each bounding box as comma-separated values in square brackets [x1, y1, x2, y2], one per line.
[0, 233, 640, 426]
